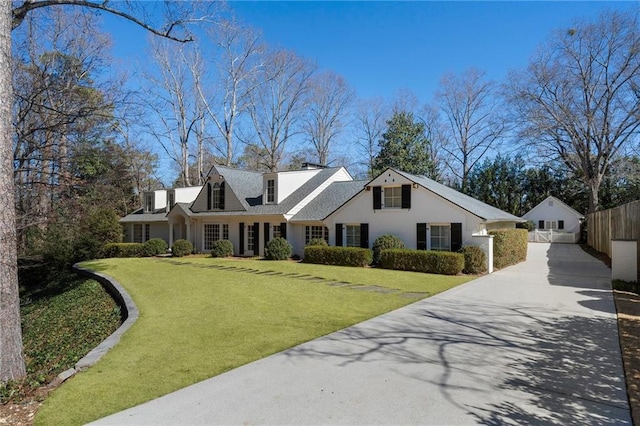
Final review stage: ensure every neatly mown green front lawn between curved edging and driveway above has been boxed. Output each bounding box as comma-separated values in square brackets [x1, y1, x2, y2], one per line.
[36, 257, 473, 425]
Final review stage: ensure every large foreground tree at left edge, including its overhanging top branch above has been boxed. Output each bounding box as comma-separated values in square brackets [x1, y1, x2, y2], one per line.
[0, 0, 199, 383]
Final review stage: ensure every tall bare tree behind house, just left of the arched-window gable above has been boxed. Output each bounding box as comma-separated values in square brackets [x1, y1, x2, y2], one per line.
[143, 39, 204, 186]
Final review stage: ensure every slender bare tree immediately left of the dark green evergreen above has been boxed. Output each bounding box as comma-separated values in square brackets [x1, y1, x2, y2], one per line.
[354, 98, 390, 177]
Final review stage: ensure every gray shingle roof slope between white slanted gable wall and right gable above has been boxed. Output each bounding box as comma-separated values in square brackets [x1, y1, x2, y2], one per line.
[291, 180, 367, 222]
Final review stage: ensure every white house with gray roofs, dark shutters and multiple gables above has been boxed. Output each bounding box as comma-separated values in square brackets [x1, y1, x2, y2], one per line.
[121, 166, 524, 256]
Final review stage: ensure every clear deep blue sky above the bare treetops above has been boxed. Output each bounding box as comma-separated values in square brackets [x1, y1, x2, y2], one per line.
[105, 1, 640, 102]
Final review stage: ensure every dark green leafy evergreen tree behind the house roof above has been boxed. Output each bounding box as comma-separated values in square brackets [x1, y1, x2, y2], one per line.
[373, 111, 436, 178]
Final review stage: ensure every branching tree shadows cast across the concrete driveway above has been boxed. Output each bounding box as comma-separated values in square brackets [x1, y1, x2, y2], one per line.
[286, 299, 630, 425]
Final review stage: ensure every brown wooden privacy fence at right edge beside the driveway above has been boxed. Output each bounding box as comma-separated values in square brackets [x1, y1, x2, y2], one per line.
[587, 200, 640, 276]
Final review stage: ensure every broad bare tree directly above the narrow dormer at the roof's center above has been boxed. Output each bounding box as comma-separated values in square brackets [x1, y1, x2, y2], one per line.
[248, 50, 316, 171]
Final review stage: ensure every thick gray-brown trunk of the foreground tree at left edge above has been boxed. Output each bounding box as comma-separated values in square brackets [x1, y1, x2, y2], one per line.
[0, 1, 26, 383]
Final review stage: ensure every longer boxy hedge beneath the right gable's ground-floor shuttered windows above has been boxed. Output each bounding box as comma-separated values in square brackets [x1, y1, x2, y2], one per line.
[380, 249, 464, 275]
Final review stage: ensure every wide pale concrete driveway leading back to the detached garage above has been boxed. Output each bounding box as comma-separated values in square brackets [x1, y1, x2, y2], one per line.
[90, 244, 631, 425]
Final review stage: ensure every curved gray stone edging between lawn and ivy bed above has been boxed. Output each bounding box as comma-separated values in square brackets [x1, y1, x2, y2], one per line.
[51, 264, 138, 387]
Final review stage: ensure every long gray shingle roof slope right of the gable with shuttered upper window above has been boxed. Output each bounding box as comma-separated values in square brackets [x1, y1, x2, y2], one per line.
[392, 169, 525, 222]
